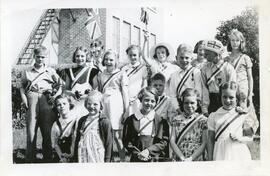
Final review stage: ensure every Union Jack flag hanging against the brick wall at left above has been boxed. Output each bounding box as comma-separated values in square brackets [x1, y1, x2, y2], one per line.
[85, 8, 102, 40]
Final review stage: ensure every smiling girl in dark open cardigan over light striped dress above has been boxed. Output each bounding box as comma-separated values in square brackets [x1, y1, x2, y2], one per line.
[74, 90, 113, 163]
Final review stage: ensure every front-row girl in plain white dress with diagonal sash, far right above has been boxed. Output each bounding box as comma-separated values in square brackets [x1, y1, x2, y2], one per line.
[208, 82, 256, 161]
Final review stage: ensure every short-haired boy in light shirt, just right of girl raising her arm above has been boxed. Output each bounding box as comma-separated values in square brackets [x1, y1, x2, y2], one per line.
[169, 44, 209, 114]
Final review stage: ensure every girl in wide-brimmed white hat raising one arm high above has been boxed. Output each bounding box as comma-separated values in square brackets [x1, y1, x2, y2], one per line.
[142, 32, 178, 91]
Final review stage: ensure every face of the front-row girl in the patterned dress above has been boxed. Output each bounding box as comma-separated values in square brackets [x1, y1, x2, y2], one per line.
[183, 96, 198, 116]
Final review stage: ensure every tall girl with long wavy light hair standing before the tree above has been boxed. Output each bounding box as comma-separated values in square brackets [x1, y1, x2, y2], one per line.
[225, 29, 253, 107]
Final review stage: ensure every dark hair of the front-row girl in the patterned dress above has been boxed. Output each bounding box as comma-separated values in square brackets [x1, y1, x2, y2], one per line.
[177, 88, 202, 113]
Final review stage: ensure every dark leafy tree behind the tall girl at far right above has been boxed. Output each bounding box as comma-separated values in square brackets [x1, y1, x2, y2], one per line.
[216, 7, 260, 122]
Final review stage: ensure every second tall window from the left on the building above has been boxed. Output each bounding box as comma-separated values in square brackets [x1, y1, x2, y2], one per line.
[122, 21, 131, 62]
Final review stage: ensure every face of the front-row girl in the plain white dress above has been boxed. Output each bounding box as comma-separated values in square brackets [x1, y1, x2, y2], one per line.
[221, 89, 236, 110]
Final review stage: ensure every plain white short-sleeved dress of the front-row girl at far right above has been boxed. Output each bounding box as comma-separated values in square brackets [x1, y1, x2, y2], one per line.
[208, 107, 251, 161]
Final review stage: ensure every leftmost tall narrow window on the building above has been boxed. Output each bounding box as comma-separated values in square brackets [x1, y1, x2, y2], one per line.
[112, 17, 120, 53]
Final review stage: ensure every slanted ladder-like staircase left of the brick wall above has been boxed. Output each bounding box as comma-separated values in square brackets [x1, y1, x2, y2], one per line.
[17, 9, 56, 65]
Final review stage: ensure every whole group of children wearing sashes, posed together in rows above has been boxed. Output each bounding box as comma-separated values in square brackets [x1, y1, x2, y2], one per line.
[21, 30, 258, 162]
